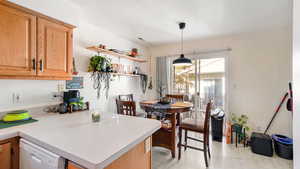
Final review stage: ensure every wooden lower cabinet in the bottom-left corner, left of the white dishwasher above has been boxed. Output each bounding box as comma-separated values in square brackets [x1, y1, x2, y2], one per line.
[0, 137, 19, 169]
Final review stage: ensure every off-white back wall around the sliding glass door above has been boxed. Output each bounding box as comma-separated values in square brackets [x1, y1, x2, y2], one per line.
[151, 28, 292, 136]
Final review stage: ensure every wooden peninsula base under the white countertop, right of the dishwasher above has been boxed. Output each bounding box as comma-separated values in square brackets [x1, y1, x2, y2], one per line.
[68, 137, 152, 169]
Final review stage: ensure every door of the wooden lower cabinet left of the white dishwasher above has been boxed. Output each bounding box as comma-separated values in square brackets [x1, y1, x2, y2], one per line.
[0, 143, 12, 169]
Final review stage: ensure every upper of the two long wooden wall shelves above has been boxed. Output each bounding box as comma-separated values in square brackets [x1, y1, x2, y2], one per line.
[87, 46, 147, 63]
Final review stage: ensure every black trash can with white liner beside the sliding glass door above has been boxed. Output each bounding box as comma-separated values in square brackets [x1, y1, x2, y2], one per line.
[211, 109, 225, 142]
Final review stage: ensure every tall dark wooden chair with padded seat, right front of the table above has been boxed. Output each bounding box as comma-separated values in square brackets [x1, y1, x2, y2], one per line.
[178, 102, 211, 167]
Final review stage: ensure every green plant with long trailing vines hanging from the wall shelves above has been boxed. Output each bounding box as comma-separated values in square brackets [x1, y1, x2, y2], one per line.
[88, 55, 113, 99]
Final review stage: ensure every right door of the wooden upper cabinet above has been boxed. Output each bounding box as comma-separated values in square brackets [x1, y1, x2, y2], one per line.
[38, 18, 73, 77]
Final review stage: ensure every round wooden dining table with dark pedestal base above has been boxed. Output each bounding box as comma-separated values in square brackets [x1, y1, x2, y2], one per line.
[140, 100, 193, 158]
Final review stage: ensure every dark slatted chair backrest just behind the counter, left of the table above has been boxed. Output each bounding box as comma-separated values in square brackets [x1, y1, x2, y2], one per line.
[116, 99, 136, 116]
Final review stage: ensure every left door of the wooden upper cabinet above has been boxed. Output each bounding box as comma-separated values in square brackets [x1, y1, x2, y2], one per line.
[0, 3, 36, 77]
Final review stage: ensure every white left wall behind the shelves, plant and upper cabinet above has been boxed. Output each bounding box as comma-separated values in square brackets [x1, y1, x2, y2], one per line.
[0, 0, 154, 112]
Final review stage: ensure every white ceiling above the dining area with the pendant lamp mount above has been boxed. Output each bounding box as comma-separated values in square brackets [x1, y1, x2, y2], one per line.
[72, 0, 292, 44]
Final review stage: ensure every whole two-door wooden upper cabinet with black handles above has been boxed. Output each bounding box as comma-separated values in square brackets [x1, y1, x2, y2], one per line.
[0, 1, 75, 80]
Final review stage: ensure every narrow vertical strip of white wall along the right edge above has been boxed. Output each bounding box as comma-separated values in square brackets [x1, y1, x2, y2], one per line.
[293, 0, 300, 169]
